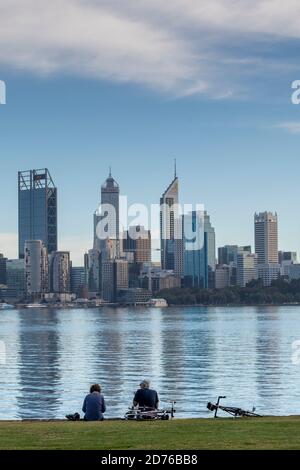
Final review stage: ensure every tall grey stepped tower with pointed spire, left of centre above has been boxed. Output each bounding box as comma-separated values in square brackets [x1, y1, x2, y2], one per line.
[94, 170, 120, 257]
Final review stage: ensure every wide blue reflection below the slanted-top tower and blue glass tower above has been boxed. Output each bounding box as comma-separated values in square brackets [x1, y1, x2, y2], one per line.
[161, 308, 214, 412]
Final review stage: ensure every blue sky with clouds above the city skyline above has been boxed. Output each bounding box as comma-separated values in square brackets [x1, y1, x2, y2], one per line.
[0, 0, 300, 265]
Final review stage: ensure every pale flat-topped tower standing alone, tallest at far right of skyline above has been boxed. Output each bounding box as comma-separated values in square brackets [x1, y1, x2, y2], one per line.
[254, 212, 278, 264]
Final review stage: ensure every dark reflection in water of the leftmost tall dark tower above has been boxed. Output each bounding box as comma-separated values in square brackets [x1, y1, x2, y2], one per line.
[17, 309, 60, 419]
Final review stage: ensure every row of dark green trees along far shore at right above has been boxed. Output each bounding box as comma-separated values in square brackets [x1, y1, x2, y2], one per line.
[157, 278, 300, 305]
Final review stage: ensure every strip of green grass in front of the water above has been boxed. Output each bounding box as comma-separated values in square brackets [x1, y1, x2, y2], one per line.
[0, 416, 300, 450]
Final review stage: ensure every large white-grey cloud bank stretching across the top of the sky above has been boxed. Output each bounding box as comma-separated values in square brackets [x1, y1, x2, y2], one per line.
[0, 0, 300, 98]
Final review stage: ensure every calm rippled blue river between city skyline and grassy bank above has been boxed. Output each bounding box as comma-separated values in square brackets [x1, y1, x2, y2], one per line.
[0, 307, 300, 419]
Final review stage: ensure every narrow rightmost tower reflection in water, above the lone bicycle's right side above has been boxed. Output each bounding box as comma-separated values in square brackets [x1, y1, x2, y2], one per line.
[255, 307, 284, 407]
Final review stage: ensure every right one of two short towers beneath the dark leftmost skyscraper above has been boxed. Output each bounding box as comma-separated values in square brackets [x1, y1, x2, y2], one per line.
[50, 251, 71, 294]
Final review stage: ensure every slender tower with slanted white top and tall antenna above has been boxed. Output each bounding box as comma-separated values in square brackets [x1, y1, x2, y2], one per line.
[160, 165, 183, 277]
